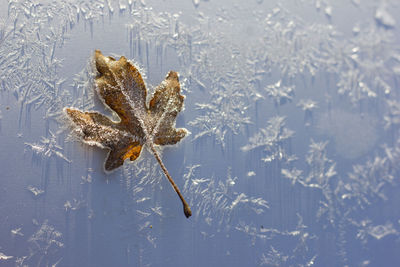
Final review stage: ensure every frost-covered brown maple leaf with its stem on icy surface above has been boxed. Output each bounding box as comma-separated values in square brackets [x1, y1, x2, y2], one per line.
[65, 50, 192, 218]
